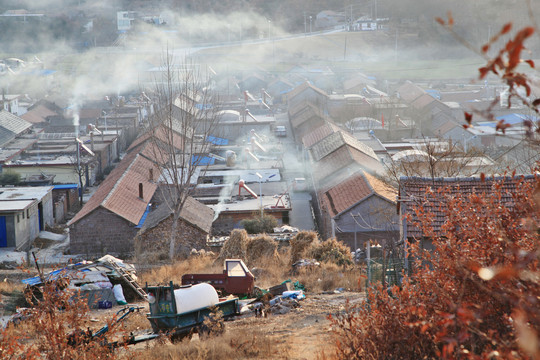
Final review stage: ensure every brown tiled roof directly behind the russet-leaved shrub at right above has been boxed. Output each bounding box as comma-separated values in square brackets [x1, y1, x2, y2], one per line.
[398, 175, 536, 238]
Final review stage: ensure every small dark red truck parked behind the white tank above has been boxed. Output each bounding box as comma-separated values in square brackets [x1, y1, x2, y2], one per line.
[182, 259, 255, 295]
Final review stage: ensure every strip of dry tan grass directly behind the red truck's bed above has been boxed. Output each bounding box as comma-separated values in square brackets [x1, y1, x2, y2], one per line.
[139, 256, 223, 285]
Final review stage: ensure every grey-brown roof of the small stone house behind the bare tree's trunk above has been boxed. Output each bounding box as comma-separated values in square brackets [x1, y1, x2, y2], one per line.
[140, 196, 214, 233]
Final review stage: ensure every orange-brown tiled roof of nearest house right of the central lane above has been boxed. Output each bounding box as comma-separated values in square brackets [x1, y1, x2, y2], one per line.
[321, 170, 397, 217]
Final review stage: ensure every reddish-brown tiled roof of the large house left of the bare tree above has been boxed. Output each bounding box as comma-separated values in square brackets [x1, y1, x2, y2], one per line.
[68, 143, 160, 225]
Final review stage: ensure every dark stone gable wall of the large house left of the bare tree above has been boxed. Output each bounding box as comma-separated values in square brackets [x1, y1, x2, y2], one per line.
[70, 207, 138, 257]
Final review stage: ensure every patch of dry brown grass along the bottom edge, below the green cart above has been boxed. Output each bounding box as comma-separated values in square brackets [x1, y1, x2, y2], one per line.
[131, 329, 285, 360]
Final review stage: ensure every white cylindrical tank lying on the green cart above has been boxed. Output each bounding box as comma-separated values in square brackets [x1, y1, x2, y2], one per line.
[174, 283, 219, 314]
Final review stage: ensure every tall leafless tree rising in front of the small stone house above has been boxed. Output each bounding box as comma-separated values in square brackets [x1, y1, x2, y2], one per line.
[143, 51, 219, 260]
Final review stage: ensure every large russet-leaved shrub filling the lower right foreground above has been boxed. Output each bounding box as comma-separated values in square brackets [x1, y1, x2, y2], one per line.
[331, 179, 540, 359]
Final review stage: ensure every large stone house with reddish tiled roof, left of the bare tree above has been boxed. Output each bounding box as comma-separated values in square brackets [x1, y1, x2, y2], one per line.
[68, 144, 160, 256]
